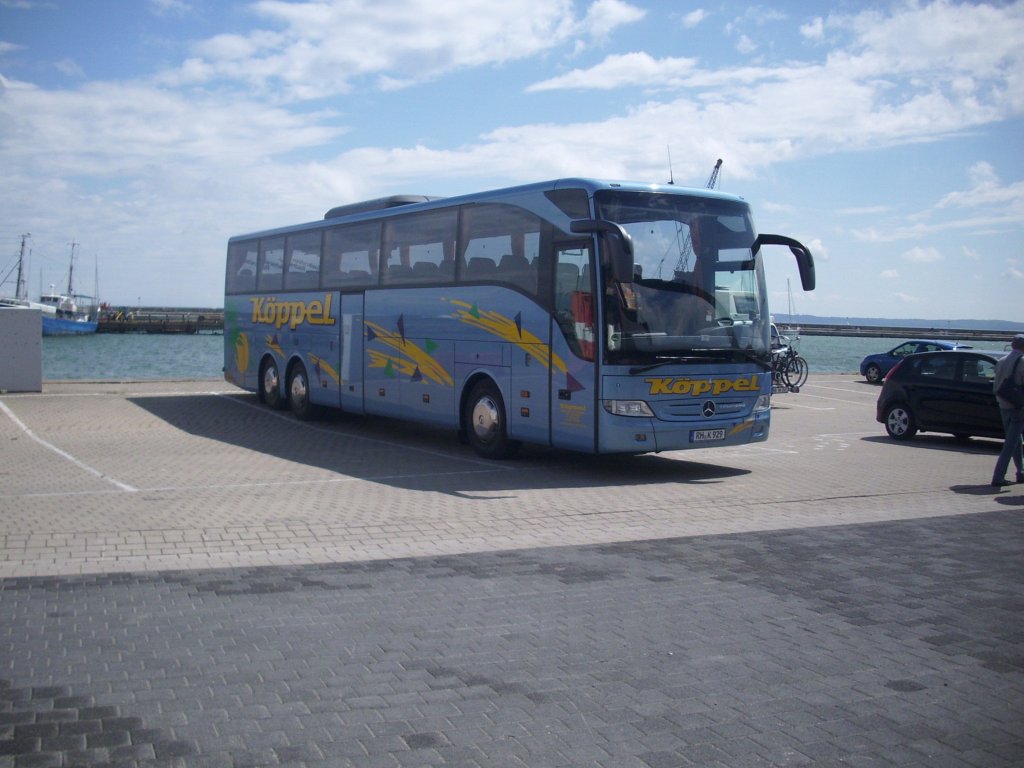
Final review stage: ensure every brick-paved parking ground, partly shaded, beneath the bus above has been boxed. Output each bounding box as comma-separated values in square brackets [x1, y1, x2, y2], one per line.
[0, 377, 1024, 768]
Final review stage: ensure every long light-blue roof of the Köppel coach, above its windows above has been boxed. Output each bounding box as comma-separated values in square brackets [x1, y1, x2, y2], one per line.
[228, 177, 742, 242]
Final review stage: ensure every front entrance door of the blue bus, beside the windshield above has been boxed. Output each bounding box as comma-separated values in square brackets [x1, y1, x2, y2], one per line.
[550, 241, 598, 453]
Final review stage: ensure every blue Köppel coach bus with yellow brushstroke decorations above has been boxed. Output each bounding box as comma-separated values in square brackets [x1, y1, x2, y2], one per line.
[224, 178, 814, 458]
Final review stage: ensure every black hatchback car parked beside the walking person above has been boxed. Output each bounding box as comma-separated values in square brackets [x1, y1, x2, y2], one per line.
[876, 350, 1006, 440]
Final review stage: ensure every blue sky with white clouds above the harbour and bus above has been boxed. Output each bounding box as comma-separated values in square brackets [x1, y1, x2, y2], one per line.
[0, 0, 1024, 322]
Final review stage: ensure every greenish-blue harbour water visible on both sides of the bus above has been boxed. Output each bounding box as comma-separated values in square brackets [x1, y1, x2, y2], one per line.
[43, 334, 983, 381]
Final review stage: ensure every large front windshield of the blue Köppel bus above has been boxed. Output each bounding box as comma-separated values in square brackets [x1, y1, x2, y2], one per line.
[595, 190, 769, 365]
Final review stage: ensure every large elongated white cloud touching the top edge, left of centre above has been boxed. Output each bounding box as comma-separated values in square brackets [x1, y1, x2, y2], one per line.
[162, 0, 645, 99]
